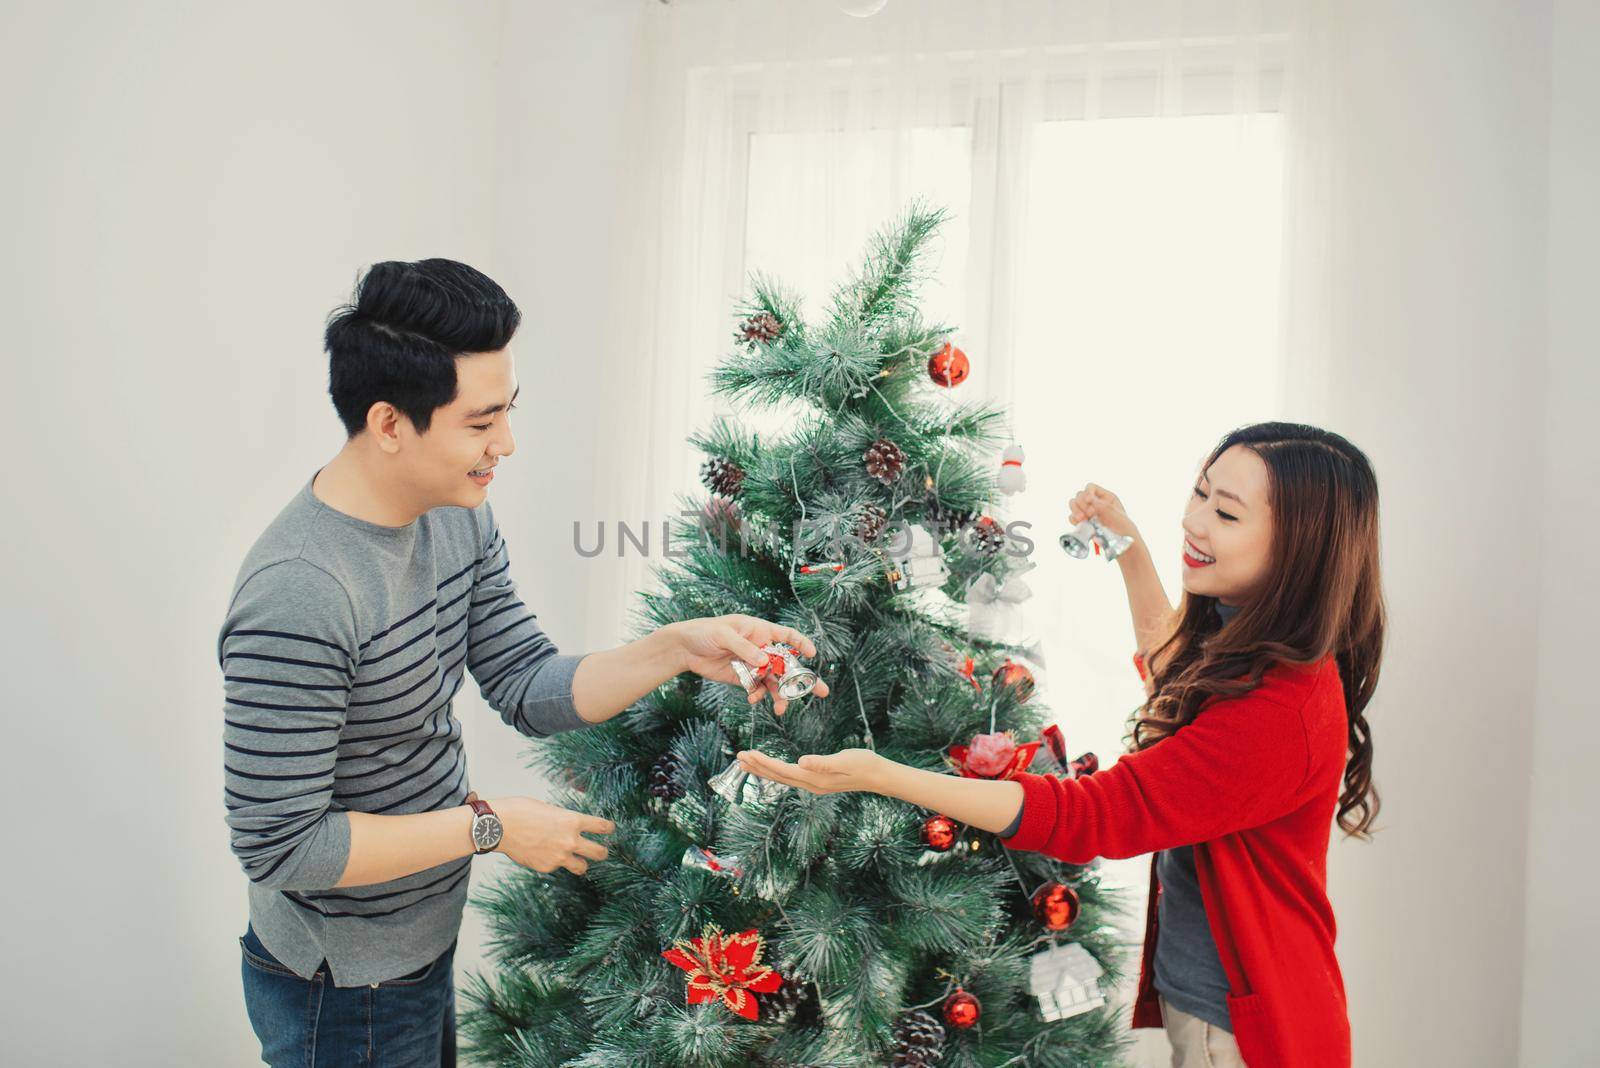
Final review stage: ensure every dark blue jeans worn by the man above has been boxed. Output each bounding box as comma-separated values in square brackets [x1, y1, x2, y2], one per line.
[238, 927, 456, 1068]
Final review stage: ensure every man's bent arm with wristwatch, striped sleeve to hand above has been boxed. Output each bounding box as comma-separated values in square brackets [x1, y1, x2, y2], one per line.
[228, 549, 613, 891]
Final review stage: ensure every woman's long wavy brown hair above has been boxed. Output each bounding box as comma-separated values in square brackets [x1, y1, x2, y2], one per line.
[1131, 422, 1384, 838]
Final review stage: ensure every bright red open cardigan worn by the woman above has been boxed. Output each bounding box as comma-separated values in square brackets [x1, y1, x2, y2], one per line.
[1003, 657, 1350, 1068]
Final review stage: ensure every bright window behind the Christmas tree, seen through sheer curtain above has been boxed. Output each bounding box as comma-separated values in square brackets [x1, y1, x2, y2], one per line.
[728, 66, 1283, 965]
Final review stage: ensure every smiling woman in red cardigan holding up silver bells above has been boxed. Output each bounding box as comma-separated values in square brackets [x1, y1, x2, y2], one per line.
[739, 422, 1384, 1068]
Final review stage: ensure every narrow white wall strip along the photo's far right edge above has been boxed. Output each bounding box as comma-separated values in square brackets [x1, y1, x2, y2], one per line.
[1520, 0, 1600, 1068]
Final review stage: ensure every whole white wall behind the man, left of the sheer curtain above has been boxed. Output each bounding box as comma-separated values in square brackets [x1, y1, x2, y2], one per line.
[0, 0, 637, 1065]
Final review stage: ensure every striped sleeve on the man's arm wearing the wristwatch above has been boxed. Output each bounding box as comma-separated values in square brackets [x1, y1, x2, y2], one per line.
[218, 560, 357, 891]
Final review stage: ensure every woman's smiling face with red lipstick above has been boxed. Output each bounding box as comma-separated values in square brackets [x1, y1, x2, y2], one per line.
[1184, 444, 1272, 604]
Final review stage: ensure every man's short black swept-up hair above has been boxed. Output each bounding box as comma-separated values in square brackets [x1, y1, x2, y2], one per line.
[323, 259, 522, 438]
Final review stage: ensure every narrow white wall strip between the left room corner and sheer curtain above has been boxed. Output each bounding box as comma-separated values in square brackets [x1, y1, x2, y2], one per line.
[456, 0, 642, 978]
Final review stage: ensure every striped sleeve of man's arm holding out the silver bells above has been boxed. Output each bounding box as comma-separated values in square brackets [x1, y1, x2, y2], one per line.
[467, 502, 589, 739]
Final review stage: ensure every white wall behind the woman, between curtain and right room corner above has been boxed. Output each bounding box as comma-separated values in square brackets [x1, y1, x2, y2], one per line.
[1286, 0, 1561, 1068]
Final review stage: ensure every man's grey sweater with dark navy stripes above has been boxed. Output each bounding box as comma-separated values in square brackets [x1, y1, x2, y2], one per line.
[218, 476, 586, 986]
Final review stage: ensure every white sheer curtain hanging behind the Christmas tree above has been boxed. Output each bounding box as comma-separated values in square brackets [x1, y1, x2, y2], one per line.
[592, 0, 1288, 626]
